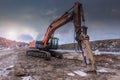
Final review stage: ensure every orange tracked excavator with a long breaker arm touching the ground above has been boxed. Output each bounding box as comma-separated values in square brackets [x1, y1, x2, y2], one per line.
[27, 2, 96, 71]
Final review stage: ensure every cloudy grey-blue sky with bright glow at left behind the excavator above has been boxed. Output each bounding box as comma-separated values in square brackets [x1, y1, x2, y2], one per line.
[0, 0, 120, 44]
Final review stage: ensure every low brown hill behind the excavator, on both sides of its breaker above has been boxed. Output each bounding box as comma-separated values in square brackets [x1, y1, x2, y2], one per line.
[59, 39, 120, 51]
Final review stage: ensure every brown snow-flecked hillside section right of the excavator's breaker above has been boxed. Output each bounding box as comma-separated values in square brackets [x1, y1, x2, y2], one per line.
[91, 39, 120, 52]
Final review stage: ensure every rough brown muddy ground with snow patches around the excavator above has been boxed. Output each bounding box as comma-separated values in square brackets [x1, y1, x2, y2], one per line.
[0, 49, 120, 80]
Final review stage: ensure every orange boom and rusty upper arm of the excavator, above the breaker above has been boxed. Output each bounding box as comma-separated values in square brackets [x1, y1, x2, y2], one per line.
[43, 2, 85, 47]
